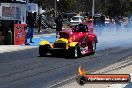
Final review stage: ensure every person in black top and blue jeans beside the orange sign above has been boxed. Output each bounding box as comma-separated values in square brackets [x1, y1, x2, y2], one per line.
[25, 12, 35, 45]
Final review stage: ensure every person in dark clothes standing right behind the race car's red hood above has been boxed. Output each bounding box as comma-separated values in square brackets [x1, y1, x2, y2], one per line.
[55, 15, 63, 38]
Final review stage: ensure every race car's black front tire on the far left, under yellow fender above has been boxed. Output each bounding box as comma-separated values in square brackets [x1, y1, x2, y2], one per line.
[39, 45, 50, 57]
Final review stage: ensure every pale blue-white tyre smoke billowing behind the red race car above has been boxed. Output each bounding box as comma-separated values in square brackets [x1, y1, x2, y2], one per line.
[94, 24, 132, 50]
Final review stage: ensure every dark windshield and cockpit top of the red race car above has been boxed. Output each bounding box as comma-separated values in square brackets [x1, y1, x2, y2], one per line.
[72, 24, 88, 32]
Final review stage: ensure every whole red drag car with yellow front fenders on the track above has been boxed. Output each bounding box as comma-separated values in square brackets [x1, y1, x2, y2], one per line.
[39, 23, 97, 58]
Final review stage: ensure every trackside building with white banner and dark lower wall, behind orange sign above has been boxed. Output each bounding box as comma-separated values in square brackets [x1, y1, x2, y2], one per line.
[0, 0, 38, 45]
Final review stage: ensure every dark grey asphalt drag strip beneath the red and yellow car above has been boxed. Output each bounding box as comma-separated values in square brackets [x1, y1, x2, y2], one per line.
[0, 44, 132, 88]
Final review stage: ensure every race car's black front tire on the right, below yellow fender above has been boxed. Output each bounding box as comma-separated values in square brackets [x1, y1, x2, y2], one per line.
[67, 45, 81, 59]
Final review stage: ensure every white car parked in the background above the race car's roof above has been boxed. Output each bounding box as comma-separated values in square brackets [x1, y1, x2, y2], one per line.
[70, 16, 84, 27]
